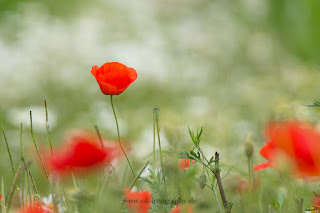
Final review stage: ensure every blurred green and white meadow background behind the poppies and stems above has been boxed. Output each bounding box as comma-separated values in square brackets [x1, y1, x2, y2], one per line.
[0, 0, 320, 213]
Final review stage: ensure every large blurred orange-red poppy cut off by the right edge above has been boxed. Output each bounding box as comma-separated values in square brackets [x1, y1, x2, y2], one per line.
[254, 120, 320, 178]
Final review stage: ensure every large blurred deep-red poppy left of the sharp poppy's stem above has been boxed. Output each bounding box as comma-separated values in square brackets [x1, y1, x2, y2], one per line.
[47, 132, 120, 175]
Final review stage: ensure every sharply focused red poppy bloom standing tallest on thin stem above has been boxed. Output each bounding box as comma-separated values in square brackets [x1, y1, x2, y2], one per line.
[91, 62, 137, 95]
